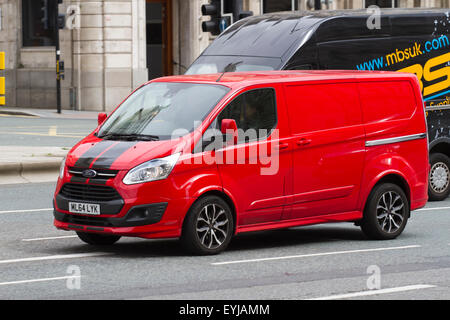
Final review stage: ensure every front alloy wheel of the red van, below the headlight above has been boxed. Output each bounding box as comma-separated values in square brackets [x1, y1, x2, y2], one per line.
[181, 196, 234, 254]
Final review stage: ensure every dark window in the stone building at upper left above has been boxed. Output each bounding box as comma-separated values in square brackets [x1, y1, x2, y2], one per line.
[22, 0, 58, 47]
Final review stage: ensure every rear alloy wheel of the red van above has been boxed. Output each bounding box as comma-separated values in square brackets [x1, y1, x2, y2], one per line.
[361, 183, 410, 240]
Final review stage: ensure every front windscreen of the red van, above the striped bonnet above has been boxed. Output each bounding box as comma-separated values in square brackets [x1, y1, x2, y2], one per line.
[97, 82, 229, 140]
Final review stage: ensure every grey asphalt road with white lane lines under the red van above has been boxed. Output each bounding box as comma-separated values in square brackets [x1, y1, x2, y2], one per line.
[0, 183, 450, 300]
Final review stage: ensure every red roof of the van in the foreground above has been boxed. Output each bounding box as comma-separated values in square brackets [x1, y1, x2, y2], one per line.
[150, 70, 415, 87]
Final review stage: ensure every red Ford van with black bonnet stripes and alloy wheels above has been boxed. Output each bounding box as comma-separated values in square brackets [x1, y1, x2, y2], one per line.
[54, 71, 429, 254]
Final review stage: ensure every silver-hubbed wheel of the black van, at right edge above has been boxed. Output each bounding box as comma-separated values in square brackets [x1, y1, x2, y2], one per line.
[428, 153, 450, 201]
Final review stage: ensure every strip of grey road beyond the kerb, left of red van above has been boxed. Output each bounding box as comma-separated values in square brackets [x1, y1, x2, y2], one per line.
[0, 115, 97, 147]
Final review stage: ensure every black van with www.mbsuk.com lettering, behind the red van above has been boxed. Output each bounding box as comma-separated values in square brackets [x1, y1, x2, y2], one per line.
[186, 9, 450, 200]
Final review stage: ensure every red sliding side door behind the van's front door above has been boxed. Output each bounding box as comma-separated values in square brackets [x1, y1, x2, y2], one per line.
[283, 81, 364, 219]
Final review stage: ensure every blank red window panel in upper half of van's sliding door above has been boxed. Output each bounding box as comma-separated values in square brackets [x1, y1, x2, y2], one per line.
[286, 83, 361, 134]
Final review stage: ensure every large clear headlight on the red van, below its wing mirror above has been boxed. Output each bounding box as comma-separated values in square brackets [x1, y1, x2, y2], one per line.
[123, 153, 180, 184]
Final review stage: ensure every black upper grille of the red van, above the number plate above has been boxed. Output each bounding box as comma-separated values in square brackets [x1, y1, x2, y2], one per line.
[60, 183, 122, 201]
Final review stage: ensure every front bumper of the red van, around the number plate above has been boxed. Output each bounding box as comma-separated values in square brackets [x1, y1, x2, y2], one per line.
[53, 166, 202, 238]
